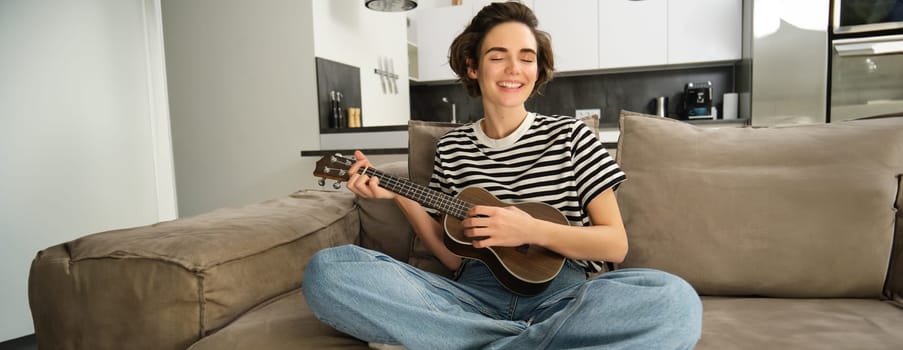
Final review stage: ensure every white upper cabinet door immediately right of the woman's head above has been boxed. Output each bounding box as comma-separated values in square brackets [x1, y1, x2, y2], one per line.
[533, 0, 600, 72]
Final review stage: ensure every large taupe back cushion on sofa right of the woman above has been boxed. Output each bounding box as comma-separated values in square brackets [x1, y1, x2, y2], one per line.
[617, 115, 903, 298]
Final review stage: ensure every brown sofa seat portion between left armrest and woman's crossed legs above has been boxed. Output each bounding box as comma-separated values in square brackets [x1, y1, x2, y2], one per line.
[188, 290, 368, 350]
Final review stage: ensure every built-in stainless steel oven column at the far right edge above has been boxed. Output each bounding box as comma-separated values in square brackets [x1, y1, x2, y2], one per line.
[828, 0, 903, 121]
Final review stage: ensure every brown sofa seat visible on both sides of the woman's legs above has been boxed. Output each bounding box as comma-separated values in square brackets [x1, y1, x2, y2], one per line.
[178, 292, 903, 350]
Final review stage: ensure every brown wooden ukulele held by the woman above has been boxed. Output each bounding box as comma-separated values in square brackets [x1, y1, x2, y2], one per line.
[314, 154, 568, 295]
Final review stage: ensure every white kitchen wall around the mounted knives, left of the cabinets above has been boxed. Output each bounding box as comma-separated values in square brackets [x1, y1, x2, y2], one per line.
[313, 0, 411, 127]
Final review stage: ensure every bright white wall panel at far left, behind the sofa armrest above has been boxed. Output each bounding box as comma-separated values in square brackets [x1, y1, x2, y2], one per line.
[0, 0, 176, 341]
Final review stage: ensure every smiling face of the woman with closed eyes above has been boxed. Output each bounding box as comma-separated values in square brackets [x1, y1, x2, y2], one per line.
[467, 22, 538, 111]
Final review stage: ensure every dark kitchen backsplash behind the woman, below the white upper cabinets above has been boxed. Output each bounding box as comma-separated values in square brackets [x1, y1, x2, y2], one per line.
[411, 65, 743, 125]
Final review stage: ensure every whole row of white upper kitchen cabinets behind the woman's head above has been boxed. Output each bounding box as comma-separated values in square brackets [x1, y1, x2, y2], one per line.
[415, 0, 742, 82]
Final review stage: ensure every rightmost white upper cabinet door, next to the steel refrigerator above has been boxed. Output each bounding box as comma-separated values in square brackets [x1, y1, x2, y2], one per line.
[668, 0, 743, 64]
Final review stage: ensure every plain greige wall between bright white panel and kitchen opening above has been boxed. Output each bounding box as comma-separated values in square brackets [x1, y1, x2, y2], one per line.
[163, 0, 320, 216]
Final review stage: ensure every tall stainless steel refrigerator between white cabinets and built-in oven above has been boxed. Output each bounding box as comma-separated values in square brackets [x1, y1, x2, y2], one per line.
[737, 0, 831, 126]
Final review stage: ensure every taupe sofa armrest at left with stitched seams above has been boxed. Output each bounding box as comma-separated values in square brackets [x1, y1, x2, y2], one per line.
[29, 191, 360, 349]
